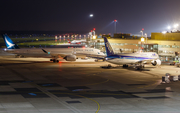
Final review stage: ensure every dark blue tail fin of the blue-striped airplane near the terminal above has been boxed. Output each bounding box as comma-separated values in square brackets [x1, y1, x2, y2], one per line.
[104, 37, 114, 56]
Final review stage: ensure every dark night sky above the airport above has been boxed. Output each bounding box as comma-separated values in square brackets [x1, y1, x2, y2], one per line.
[0, 0, 180, 35]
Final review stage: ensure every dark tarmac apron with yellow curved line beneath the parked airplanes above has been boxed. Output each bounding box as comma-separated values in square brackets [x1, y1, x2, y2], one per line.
[0, 53, 180, 113]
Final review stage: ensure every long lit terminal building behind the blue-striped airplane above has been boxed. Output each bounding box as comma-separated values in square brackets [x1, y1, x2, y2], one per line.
[94, 32, 180, 61]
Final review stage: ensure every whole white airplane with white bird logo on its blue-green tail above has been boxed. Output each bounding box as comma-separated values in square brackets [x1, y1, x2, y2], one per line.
[3, 35, 104, 62]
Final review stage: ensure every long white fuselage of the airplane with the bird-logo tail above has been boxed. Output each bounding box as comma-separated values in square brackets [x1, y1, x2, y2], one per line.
[4, 48, 104, 57]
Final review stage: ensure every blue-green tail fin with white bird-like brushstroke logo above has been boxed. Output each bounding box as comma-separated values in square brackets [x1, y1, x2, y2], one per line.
[2, 34, 19, 49]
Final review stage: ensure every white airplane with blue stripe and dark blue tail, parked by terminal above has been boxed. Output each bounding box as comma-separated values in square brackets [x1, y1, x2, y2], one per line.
[104, 37, 161, 69]
